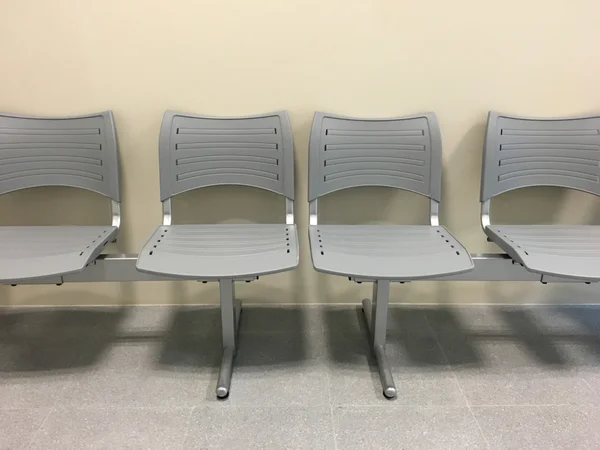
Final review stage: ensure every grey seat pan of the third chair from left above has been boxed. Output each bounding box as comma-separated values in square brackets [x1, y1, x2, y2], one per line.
[309, 225, 473, 281]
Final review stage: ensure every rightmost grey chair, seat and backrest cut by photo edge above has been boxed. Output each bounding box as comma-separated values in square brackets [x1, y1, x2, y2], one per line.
[481, 112, 600, 282]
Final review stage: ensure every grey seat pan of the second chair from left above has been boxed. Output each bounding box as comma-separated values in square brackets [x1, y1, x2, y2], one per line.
[137, 224, 298, 280]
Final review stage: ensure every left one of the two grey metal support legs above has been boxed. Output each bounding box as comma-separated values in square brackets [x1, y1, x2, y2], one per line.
[217, 278, 242, 399]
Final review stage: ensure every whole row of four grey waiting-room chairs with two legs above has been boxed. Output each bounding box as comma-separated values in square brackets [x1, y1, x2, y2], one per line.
[0, 112, 600, 398]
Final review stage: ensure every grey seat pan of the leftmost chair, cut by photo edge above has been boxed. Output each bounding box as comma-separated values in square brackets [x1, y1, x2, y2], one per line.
[0, 226, 118, 282]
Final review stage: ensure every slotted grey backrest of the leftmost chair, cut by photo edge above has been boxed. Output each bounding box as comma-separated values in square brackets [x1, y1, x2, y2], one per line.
[0, 111, 120, 202]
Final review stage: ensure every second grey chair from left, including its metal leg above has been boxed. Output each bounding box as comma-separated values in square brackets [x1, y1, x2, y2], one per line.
[137, 112, 298, 398]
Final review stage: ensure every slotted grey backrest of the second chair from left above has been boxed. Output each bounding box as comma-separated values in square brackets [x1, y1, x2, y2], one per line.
[159, 111, 294, 201]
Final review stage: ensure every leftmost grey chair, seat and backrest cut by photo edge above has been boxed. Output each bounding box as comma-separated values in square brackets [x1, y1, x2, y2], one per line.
[0, 111, 120, 284]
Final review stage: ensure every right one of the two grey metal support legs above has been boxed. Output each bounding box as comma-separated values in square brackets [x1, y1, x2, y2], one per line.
[362, 280, 396, 399]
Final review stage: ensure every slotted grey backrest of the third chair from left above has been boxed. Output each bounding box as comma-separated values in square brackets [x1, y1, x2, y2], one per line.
[308, 112, 442, 202]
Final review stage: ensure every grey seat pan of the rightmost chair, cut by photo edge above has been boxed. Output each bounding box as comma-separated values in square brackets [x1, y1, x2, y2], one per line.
[485, 225, 600, 281]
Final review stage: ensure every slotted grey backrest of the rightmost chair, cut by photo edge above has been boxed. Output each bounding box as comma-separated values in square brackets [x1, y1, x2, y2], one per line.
[481, 112, 600, 202]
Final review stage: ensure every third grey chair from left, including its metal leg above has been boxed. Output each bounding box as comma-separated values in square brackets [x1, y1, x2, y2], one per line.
[308, 113, 473, 398]
